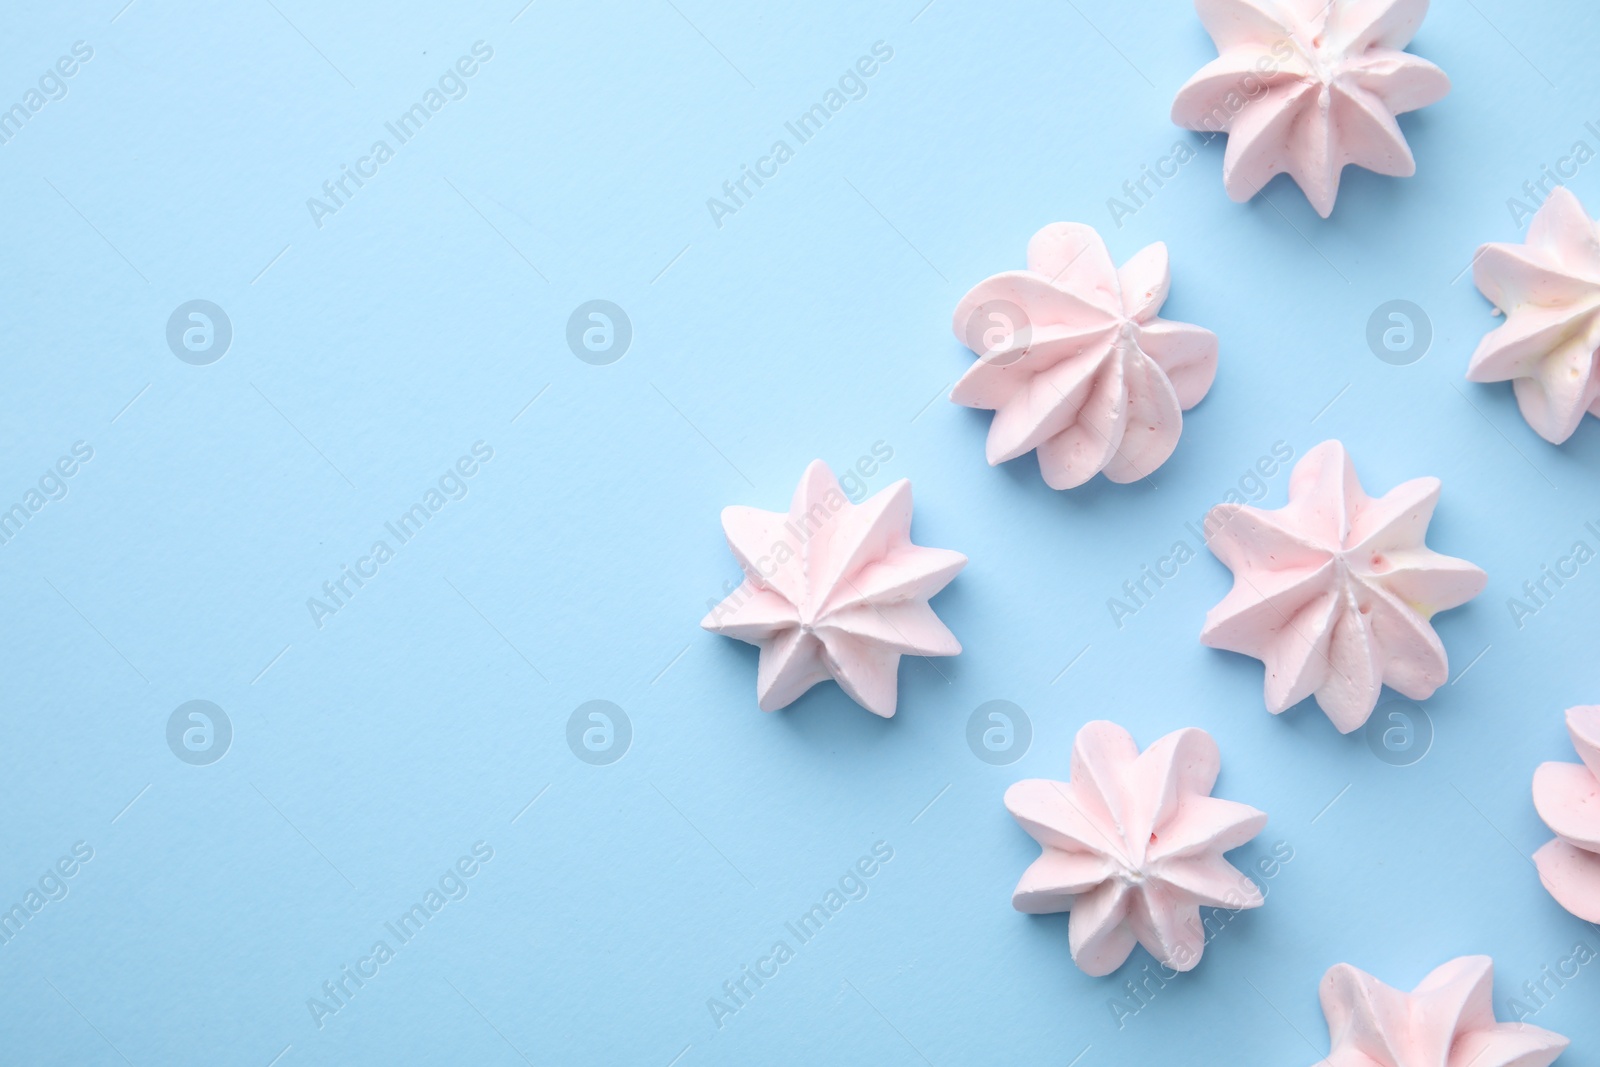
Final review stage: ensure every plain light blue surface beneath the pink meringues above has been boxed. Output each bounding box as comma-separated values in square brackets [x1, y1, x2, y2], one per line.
[0, 0, 1600, 1067]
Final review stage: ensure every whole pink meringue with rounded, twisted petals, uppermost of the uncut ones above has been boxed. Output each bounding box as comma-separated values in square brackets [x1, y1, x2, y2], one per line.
[950, 222, 1216, 490]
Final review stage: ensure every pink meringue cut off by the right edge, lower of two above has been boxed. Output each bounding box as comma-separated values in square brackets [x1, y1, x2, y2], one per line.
[1533, 705, 1600, 923]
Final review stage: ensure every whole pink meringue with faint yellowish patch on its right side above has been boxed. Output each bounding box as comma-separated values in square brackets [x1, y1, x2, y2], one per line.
[1200, 442, 1488, 734]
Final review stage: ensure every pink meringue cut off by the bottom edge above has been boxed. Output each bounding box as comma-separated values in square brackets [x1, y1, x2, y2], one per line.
[1318, 957, 1570, 1067]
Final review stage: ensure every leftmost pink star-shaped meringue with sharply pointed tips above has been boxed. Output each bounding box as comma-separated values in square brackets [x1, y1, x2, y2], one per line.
[701, 459, 966, 717]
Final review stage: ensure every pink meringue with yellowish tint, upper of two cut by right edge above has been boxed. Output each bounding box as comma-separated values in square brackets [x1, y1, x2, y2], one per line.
[1467, 186, 1600, 445]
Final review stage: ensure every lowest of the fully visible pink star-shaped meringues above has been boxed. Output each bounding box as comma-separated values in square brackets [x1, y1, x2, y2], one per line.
[1005, 721, 1267, 977]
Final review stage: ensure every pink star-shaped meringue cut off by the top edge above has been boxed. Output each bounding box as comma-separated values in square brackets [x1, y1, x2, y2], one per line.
[1173, 0, 1450, 218]
